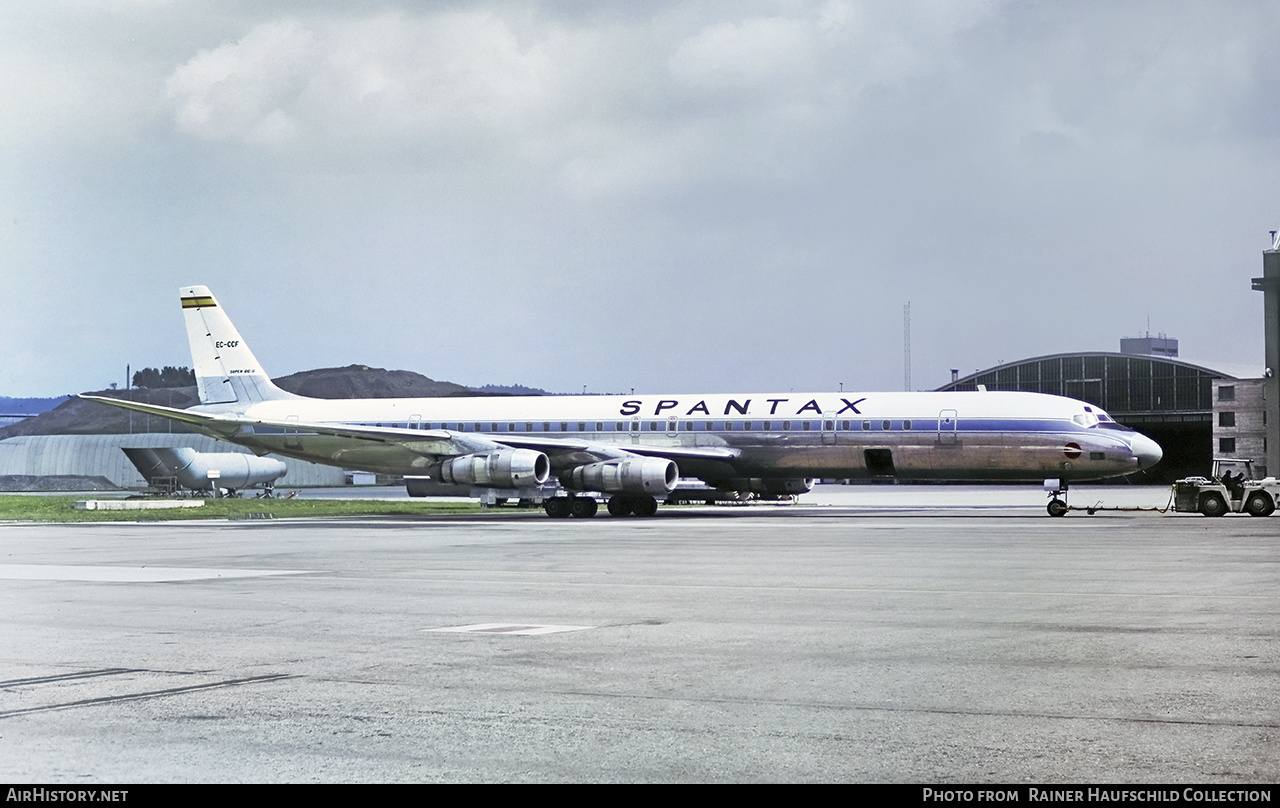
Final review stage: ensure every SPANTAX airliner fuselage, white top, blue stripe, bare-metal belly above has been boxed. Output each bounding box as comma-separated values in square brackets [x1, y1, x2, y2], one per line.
[198, 392, 1158, 481]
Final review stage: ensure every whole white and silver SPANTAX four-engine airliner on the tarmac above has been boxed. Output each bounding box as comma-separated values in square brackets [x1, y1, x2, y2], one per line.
[83, 286, 1162, 517]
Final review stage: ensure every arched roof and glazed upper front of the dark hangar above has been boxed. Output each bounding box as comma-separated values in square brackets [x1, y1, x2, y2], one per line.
[938, 352, 1235, 426]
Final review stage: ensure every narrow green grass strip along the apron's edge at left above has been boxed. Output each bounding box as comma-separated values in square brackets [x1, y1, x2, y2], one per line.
[0, 494, 480, 522]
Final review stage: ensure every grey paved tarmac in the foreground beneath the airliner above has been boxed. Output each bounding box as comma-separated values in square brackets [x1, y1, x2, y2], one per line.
[0, 487, 1280, 785]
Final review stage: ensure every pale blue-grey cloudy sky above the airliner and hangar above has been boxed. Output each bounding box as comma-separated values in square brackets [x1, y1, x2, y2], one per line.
[0, 0, 1280, 396]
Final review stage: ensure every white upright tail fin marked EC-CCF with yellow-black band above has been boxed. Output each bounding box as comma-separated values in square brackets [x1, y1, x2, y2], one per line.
[179, 286, 302, 405]
